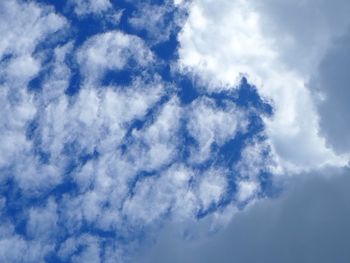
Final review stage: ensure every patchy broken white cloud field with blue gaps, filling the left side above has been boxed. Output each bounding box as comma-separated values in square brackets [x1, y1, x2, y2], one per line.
[0, 0, 272, 262]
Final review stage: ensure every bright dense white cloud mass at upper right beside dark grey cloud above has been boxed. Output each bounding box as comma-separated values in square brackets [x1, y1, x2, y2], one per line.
[179, 0, 350, 171]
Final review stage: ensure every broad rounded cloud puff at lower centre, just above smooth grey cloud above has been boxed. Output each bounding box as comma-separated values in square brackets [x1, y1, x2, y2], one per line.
[123, 164, 198, 225]
